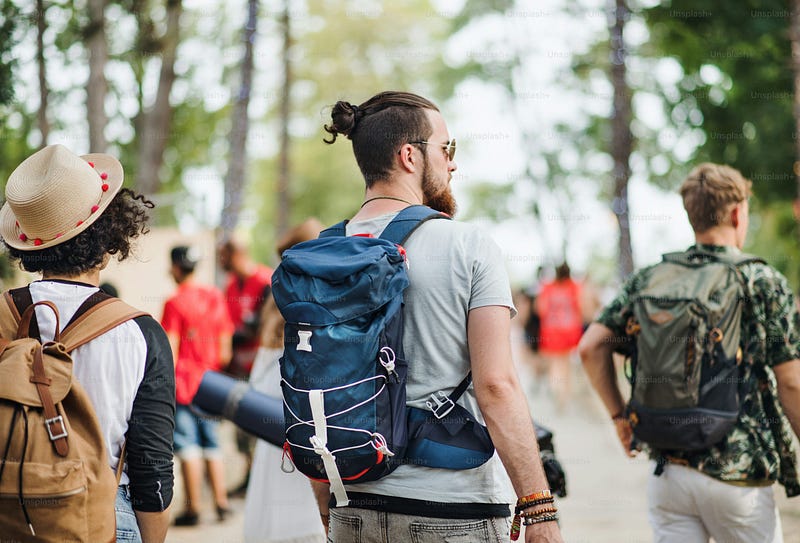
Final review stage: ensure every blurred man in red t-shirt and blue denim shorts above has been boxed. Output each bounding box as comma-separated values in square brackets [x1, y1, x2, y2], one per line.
[161, 246, 233, 526]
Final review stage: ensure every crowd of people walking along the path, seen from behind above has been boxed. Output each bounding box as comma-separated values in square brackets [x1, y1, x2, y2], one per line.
[0, 92, 800, 543]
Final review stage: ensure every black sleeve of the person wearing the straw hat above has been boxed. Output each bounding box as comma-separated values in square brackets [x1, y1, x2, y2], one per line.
[127, 316, 175, 512]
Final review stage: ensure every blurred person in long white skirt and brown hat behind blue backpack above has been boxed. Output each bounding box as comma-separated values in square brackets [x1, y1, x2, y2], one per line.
[244, 218, 325, 543]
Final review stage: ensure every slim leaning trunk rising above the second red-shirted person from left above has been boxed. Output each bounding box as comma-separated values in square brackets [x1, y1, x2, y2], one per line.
[219, 0, 258, 239]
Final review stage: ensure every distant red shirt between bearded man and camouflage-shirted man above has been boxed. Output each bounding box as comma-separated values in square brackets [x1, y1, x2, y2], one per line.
[536, 279, 583, 354]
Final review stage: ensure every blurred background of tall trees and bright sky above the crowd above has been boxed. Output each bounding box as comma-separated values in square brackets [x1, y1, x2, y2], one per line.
[0, 0, 800, 287]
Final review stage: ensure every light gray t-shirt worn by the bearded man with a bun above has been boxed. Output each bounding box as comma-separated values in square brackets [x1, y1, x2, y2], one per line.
[347, 213, 516, 504]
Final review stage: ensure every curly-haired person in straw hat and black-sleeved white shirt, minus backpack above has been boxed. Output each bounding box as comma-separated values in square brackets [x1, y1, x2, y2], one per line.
[0, 145, 175, 543]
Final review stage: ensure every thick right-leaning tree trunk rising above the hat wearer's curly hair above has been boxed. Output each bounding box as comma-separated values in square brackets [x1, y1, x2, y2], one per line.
[136, 0, 183, 195]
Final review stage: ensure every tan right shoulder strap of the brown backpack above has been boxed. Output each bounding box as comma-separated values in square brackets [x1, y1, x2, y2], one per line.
[61, 293, 147, 352]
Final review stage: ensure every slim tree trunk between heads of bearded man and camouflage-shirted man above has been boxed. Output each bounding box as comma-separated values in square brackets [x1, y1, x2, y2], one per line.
[609, 0, 633, 279]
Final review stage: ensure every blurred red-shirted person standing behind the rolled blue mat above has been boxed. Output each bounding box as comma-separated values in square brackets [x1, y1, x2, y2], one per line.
[219, 238, 272, 496]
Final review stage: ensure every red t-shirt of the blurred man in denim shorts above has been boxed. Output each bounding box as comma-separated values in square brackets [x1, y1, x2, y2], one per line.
[161, 283, 233, 405]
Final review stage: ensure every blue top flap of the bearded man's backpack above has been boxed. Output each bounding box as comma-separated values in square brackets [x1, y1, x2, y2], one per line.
[272, 236, 408, 326]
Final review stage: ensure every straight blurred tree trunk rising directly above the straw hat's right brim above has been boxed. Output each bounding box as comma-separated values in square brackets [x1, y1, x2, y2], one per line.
[86, 0, 108, 153]
